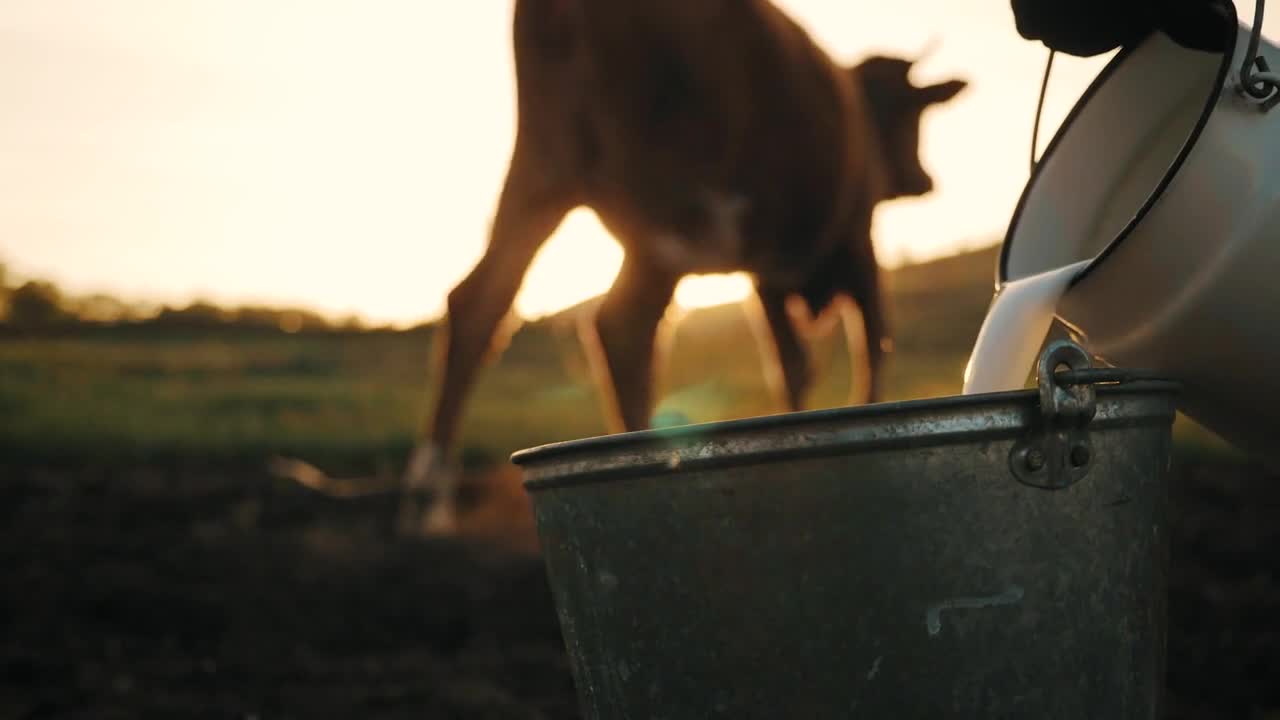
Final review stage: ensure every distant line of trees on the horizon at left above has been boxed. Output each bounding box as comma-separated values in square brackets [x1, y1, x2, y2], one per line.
[0, 264, 419, 333]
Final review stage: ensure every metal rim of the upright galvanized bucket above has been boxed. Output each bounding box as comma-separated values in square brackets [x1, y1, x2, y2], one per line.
[509, 379, 1181, 481]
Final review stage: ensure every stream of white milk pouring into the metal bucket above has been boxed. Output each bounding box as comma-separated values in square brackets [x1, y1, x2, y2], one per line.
[964, 260, 1089, 395]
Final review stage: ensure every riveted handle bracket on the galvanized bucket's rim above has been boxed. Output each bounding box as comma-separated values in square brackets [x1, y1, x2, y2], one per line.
[1009, 340, 1097, 489]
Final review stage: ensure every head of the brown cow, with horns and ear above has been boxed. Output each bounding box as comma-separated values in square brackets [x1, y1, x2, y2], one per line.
[849, 56, 968, 199]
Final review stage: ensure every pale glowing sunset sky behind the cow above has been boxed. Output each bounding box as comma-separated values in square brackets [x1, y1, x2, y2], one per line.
[0, 0, 1280, 324]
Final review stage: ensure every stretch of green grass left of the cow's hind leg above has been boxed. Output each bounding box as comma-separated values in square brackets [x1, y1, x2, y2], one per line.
[0, 333, 426, 459]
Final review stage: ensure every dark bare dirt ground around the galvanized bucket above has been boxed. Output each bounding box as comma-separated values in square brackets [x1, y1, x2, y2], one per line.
[0, 456, 1280, 720]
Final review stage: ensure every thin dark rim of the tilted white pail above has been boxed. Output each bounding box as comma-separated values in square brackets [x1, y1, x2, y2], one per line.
[996, 0, 1240, 290]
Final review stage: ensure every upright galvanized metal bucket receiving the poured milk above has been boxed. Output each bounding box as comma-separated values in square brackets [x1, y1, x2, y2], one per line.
[513, 342, 1176, 720]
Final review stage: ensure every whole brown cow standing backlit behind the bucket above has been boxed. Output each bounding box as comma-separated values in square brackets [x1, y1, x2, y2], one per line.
[401, 0, 965, 533]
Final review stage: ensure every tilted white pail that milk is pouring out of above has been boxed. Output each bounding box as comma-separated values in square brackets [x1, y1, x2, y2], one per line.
[997, 0, 1280, 465]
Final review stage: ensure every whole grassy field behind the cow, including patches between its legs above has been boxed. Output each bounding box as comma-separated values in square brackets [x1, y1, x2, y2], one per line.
[0, 243, 1249, 470]
